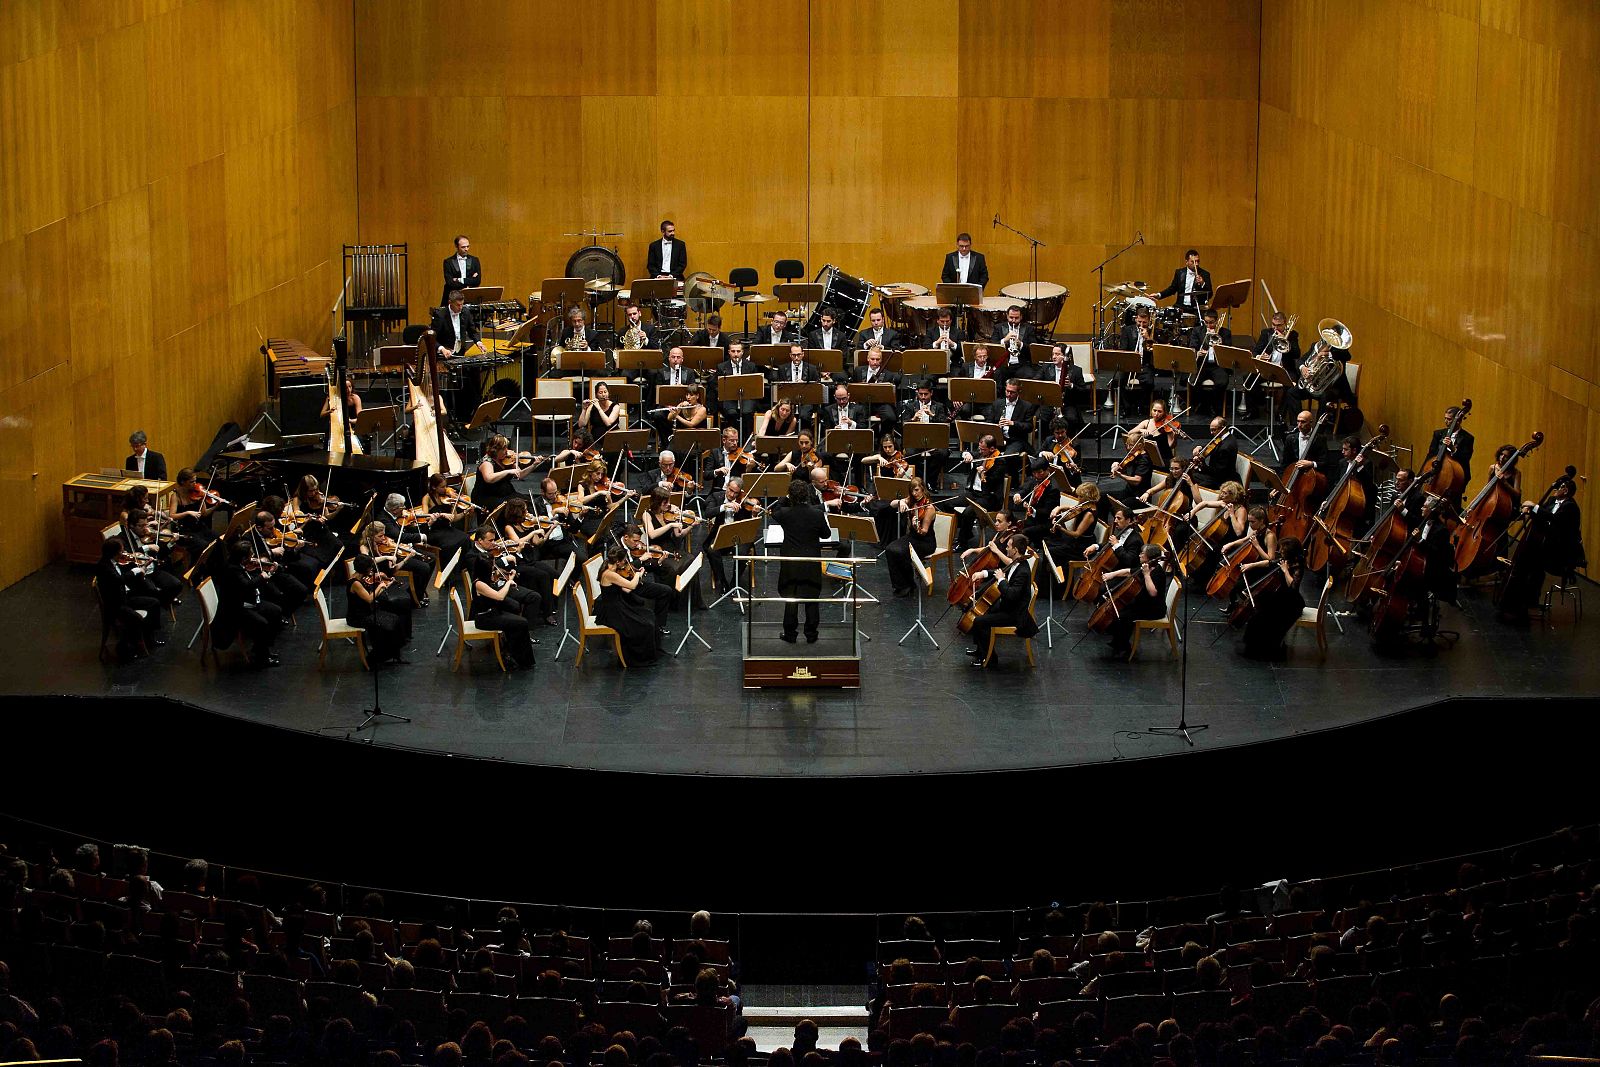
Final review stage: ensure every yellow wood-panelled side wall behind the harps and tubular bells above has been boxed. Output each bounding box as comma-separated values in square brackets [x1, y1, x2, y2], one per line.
[0, 0, 355, 585]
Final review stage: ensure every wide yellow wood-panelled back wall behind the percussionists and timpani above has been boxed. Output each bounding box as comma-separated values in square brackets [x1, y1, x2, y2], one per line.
[355, 0, 1259, 340]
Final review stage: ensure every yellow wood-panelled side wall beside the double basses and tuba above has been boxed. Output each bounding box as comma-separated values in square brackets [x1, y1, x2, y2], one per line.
[1258, 0, 1600, 557]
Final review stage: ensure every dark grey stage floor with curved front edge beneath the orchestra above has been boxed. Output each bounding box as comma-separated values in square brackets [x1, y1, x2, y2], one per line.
[0, 565, 1600, 776]
